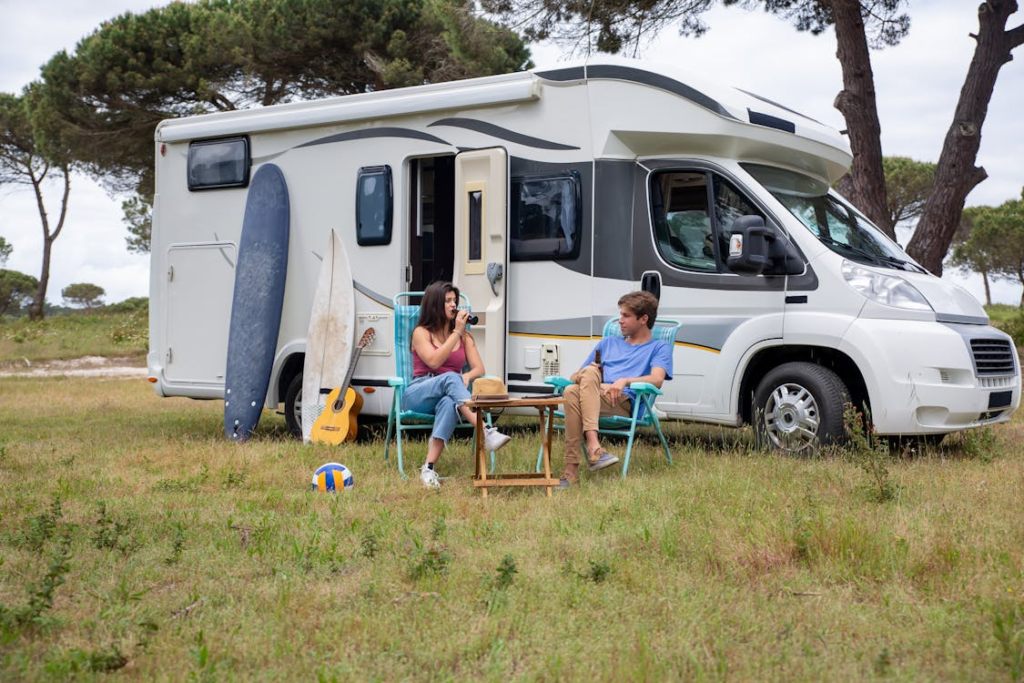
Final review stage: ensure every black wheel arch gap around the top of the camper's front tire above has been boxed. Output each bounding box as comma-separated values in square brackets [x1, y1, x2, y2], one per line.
[739, 345, 870, 424]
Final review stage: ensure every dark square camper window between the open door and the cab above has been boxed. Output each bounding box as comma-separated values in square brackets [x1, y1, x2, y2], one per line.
[509, 171, 583, 261]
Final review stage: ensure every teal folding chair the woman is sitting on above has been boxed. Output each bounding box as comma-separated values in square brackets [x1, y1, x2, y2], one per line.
[384, 292, 495, 478]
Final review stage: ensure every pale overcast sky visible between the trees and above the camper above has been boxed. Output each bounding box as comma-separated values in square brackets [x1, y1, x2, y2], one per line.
[0, 0, 1024, 303]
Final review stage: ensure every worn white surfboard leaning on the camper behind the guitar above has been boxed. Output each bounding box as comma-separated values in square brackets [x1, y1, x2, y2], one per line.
[302, 230, 355, 443]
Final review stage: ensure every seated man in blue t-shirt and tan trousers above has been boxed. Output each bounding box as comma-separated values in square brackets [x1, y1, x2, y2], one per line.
[560, 292, 672, 487]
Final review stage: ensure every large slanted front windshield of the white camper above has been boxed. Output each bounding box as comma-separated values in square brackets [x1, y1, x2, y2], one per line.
[742, 164, 926, 272]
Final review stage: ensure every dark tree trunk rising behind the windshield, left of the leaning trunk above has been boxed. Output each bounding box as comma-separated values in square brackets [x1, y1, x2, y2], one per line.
[828, 0, 896, 240]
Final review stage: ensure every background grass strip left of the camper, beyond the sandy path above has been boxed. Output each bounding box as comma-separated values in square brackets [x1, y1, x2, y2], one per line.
[0, 308, 150, 368]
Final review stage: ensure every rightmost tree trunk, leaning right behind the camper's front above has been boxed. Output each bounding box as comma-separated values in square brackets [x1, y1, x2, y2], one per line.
[907, 0, 1024, 275]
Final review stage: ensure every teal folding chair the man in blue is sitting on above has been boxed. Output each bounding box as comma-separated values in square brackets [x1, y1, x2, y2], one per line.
[537, 318, 679, 478]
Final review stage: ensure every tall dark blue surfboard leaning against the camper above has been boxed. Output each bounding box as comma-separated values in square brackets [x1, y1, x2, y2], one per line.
[224, 164, 290, 441]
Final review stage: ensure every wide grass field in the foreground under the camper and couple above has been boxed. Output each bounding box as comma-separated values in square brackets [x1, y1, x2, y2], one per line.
[0, 378, 1024, 681]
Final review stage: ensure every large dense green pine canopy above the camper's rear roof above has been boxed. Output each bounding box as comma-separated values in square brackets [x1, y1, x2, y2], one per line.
[36, 0, 529, 251]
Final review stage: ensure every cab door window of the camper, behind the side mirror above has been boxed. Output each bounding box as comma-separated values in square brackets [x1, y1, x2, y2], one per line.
[650, 171, 764, 272]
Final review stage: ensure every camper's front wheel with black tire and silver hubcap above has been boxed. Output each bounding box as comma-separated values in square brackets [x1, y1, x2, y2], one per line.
[754, 362, 850, 455]
